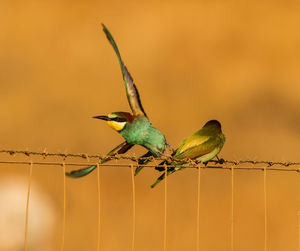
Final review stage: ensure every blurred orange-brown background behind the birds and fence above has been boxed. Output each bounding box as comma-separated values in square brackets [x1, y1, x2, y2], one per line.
[0, 0, 300, 251]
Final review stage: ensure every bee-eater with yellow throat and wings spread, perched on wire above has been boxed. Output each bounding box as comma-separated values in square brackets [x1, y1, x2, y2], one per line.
[66, 24, 167, 178]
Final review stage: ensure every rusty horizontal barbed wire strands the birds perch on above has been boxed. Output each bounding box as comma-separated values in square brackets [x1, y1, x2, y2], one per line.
[0, 150, 300, 172]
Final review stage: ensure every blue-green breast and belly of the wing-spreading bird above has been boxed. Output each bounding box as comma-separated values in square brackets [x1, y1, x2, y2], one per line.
[120, 116, 166, 157]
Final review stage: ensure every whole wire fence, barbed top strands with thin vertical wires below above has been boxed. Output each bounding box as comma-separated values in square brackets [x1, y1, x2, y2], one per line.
[0, 150, 300, 251]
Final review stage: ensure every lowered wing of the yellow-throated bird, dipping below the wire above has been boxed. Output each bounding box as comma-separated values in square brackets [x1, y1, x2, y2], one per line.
[66, 141, 133, 178]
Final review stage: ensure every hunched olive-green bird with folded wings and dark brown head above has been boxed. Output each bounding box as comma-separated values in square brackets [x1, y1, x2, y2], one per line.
[151, 120, 225, 188]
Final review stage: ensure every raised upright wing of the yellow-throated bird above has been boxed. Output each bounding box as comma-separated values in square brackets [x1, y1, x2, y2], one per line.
[102, 24, 147, 117]
